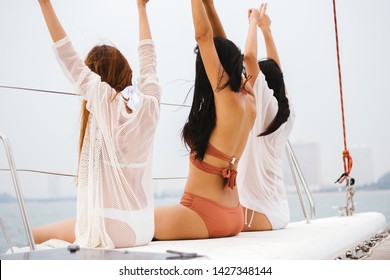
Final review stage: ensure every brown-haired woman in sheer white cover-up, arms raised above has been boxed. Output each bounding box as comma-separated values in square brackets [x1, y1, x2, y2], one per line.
[33, 0, 161, 248]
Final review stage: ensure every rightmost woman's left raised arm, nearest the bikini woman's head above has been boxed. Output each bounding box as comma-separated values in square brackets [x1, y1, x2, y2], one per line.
[244, 9, 260, 86]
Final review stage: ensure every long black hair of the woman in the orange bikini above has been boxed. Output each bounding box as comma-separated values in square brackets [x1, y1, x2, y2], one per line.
[182, 37, 243, 159]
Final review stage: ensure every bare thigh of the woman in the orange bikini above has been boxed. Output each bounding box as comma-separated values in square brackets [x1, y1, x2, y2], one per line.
[154, 205, 209, 240]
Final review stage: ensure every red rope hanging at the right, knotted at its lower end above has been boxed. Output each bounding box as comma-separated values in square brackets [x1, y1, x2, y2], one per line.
[333, 0, 352, 183]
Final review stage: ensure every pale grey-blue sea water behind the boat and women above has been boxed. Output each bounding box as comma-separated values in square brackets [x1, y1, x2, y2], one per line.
[0, 190, 390, 253]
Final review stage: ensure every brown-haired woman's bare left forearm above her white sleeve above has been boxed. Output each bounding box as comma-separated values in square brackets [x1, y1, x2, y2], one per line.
[38, 0, 66, 43]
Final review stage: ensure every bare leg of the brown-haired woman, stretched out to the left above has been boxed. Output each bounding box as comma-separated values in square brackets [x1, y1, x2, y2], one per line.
[32, 219, 76, 244]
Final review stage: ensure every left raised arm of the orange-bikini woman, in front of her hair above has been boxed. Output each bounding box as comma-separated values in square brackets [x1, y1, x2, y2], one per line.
[191, 0, 227, 91]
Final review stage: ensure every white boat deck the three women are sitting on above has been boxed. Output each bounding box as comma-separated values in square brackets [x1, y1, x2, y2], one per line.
[1, 212, 387, 260]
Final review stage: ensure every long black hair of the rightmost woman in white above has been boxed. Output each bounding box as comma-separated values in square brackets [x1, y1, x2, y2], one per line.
[258, 59, 290, 136]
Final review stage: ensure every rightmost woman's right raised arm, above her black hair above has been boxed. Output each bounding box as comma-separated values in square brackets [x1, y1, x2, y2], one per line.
[257, 3, 282, 69]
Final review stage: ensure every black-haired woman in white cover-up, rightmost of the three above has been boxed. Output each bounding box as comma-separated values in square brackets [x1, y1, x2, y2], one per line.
[237, 3, 294, 231]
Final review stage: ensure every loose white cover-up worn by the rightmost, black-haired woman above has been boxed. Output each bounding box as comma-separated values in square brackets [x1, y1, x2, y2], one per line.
[237, 72, 295, 229]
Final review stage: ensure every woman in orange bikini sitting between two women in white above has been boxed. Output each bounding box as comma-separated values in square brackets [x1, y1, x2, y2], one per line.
[154, 0, 256, 240]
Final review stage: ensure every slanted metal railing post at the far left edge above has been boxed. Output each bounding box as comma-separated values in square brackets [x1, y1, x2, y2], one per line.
[0, 133, 35, 251]
